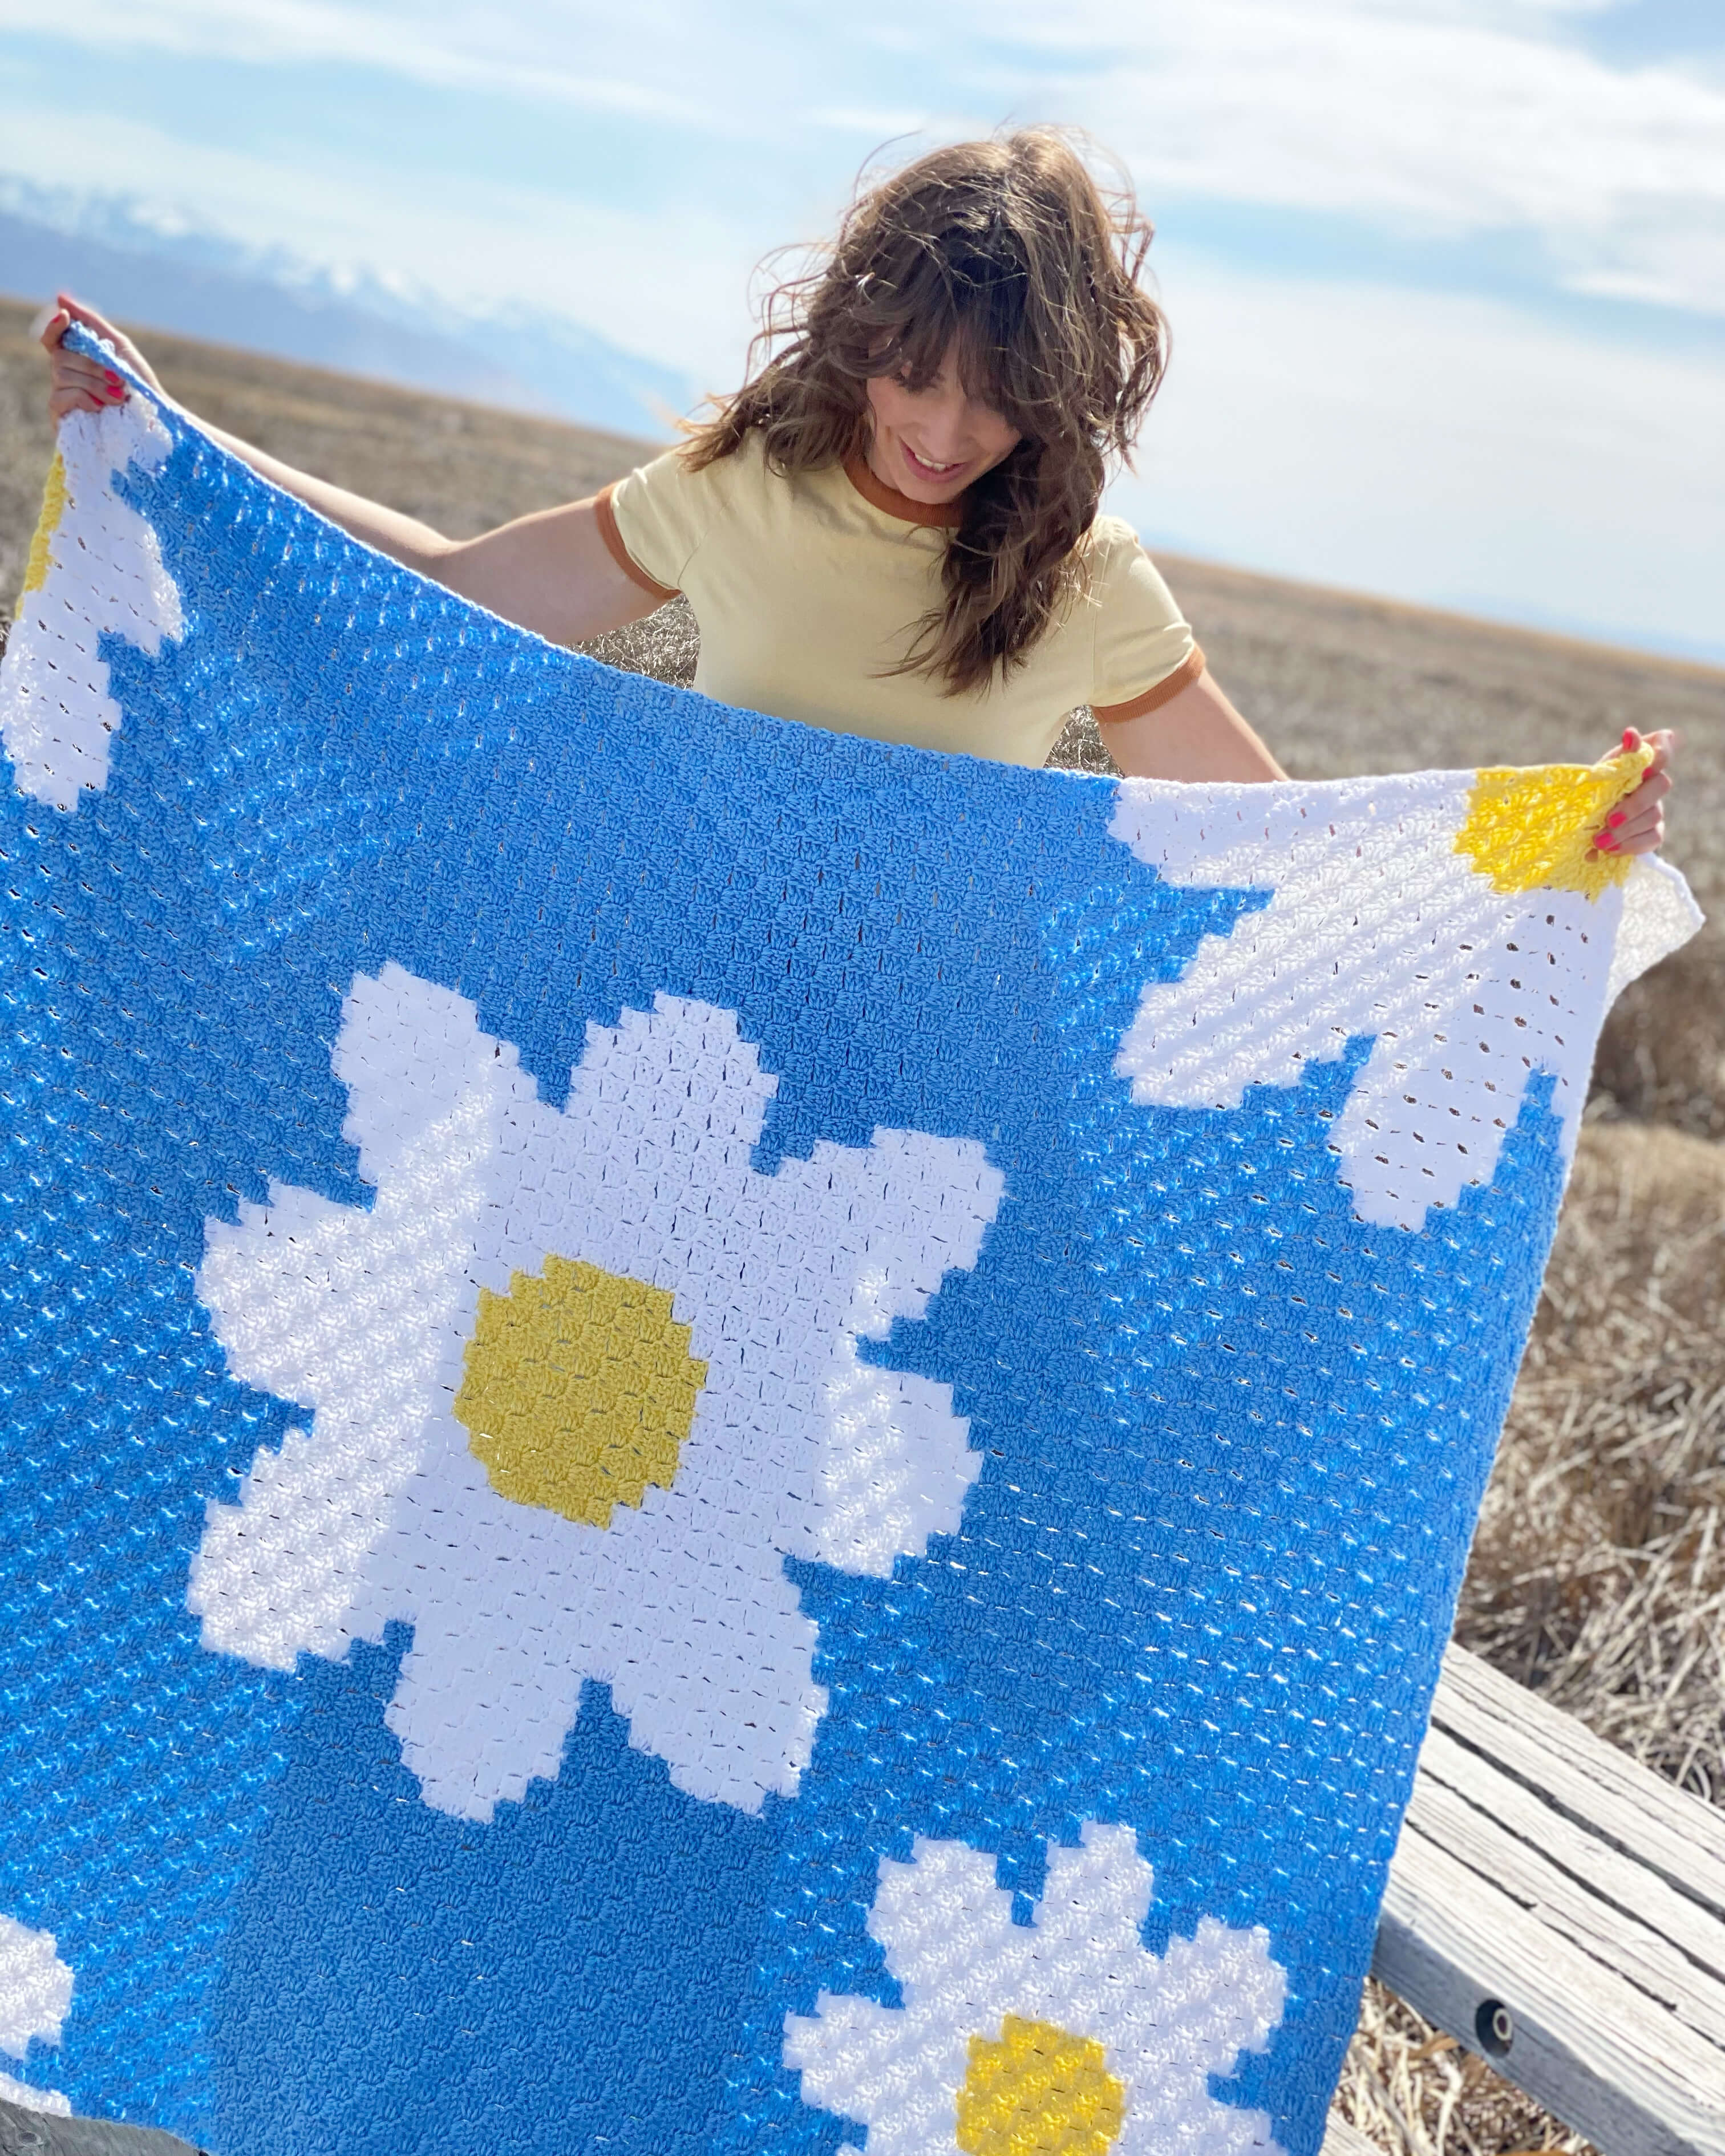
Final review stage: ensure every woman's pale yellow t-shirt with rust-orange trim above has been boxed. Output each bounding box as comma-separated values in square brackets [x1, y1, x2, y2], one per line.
[597, 433, 1203, 763]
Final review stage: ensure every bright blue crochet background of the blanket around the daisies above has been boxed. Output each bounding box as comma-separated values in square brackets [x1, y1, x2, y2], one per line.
[0, 358, 1561, 2156]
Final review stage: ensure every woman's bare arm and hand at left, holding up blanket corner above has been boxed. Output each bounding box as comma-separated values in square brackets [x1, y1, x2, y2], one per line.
[41, 295, 660, 645]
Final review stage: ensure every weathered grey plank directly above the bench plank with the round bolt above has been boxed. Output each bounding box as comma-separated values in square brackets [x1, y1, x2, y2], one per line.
[1408, 1729, 1725, 2068]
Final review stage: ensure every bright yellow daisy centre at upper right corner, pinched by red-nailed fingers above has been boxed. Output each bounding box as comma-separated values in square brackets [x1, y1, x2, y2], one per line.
[1456, 748, 1654, 899]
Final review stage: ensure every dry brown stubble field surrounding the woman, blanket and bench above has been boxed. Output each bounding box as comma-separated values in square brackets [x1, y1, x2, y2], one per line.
[0, 302, 1725, 2156]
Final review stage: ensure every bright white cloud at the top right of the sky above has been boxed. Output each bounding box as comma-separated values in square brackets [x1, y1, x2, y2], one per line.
[987, 0, 1725, 310]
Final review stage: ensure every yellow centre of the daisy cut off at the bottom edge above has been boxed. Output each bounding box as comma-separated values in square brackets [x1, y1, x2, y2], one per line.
[957, 2014, 1125, 2156]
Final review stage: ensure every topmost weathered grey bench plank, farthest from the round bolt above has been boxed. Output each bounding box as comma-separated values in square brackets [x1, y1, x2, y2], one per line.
[1432, 1647, 1725, 1923]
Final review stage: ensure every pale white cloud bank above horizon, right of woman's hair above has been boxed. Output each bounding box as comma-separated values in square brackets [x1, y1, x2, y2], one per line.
[1115, 250, 1725, 647]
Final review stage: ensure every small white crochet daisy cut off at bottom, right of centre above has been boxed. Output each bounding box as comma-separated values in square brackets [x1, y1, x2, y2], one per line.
[785, 1822, 1287, 2156]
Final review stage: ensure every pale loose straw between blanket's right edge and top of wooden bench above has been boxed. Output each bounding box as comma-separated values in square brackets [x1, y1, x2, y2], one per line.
[1457, 1119, 1725, 1802]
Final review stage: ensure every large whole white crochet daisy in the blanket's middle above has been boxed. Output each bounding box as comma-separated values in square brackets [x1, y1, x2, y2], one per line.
[188, 964, 1003, 1819]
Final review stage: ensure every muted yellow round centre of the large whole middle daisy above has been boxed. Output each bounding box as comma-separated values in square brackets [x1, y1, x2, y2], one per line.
[455, 1257, 707, 1526]
